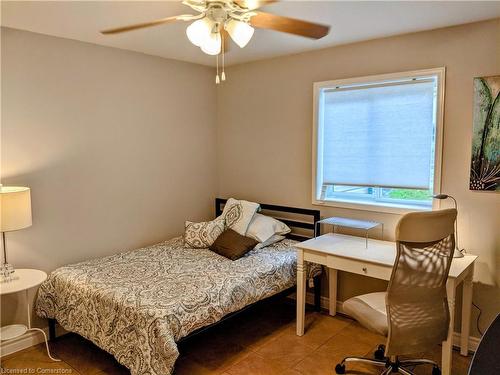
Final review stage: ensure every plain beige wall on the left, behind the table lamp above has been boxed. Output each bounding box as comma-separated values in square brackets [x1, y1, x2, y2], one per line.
[1, 28, 216, 322]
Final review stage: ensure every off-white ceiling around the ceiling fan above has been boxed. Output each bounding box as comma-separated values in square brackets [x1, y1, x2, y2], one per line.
[1, 1, 500, 65]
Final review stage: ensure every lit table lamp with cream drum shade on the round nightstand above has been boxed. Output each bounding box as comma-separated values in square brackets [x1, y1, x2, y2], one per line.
[0, 185, 31, 282]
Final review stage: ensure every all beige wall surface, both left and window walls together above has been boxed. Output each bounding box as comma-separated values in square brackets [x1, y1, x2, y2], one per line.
[1, 20, 500, 340]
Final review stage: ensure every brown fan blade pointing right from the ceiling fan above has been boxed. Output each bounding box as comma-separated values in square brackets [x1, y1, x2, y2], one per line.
[250, 12, 330, 39]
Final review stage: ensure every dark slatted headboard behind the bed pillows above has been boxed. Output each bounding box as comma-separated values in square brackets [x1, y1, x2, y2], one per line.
[215, 198, 320, 241]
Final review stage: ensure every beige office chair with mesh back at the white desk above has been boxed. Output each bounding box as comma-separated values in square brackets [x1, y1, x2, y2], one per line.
[335, 209, 457, 375]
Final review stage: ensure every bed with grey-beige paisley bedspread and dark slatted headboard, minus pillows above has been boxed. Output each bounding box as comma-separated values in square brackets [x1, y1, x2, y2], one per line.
[35, 199, 321, 375]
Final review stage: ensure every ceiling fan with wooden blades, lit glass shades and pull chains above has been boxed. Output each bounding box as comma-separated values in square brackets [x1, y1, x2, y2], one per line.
[101, 0, 330, 83]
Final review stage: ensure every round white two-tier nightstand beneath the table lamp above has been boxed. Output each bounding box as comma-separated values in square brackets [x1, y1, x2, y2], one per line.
[0, 269, 60, 361]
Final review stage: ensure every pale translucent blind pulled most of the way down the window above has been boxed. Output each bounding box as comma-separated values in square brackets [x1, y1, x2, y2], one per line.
[318, 78, 437, 189]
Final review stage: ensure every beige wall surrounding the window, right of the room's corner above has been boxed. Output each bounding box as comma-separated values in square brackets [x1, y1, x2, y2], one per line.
[217, 19, 500, 334]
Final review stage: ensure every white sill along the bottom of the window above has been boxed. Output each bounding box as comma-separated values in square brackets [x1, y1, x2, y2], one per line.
[312, 199, 432, 215]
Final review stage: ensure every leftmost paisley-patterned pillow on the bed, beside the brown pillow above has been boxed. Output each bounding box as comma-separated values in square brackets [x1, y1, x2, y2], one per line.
[184, 216, 226, 249]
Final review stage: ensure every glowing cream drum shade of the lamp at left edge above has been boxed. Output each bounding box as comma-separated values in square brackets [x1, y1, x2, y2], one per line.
[0, 186, 31, 232]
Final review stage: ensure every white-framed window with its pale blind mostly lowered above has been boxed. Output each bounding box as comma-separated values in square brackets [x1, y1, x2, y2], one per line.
[313, 68, 444, 212]
